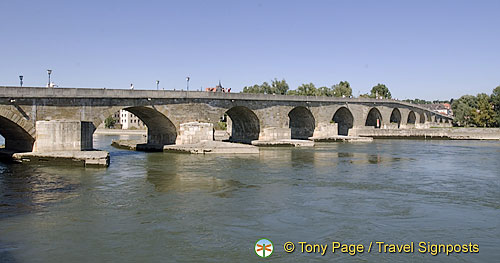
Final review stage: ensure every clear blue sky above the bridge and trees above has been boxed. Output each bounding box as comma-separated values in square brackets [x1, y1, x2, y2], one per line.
[0, 0, 500, 99]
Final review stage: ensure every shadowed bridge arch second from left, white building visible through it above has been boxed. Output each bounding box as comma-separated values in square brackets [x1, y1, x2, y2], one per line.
[123, 106, 177, 145]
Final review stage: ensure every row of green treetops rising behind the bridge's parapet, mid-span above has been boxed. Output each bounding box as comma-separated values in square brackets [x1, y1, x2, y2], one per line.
[243, 79, 392, 99]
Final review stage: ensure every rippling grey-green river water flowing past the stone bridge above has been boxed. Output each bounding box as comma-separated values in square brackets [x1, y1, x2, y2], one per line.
[0, 135, 500, 262]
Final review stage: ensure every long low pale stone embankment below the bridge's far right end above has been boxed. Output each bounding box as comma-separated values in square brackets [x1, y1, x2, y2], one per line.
[352, 128, 500, 140]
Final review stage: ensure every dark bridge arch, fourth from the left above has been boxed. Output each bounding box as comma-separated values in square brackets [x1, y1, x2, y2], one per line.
[288, 106, 316, 140]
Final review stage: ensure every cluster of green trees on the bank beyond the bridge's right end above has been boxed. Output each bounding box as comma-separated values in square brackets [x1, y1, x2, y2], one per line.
[451, 86, 500, 127]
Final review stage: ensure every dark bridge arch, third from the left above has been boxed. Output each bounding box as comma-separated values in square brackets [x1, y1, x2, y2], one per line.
[226, 106, 260, 143]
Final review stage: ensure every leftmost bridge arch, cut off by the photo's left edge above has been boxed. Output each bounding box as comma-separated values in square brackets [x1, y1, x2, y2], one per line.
[0, 109, 35, 152]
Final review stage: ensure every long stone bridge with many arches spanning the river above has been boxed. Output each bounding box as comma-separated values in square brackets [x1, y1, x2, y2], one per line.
[0, 87, 451, 151]
